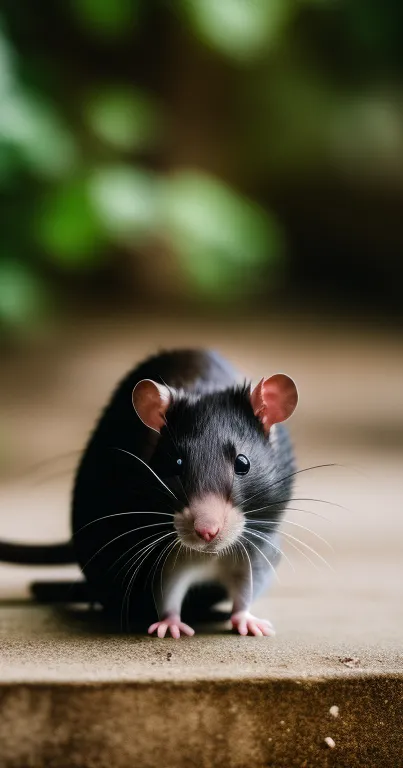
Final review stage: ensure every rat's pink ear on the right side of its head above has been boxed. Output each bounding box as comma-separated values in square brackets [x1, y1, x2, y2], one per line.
[250, 373, 298, 435]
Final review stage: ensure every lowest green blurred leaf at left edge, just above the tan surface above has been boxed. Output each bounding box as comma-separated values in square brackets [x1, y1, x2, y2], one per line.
[0, 257, 46, 325]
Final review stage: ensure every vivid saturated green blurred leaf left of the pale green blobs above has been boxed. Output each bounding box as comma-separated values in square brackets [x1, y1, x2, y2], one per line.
[36, 180, 105, 269]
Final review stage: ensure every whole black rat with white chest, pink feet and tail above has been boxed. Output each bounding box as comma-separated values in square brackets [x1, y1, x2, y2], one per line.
[0, 350, 298, 639]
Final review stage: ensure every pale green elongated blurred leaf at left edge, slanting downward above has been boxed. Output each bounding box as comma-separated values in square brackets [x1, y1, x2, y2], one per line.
[0, 92, 76, 177]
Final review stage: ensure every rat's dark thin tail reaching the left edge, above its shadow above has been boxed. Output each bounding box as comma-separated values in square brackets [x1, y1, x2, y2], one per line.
[0, 541, 77, 565]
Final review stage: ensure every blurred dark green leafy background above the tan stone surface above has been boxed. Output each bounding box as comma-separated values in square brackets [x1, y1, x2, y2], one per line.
[0, 0, 403, 336]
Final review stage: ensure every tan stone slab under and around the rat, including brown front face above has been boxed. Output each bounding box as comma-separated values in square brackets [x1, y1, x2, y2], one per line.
[0, 318, 403, 768]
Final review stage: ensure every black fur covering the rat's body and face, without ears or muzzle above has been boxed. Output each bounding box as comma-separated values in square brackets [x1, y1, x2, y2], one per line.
[73, 351, 294, 620]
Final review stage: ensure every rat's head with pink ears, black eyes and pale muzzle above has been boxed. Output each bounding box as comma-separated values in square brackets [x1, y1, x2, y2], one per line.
[133, 373, 298, 554]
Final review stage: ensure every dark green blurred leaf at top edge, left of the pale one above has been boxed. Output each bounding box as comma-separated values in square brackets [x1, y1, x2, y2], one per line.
[73, 0, 138, 37]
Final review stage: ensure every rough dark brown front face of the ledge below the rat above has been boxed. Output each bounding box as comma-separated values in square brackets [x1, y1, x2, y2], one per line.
[0, 676, 403, 768]
